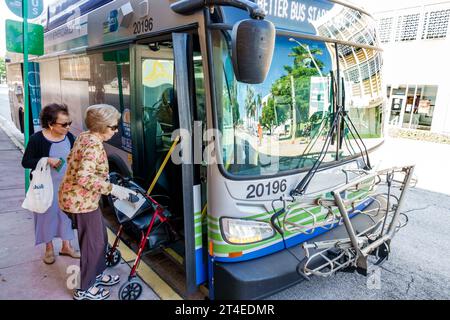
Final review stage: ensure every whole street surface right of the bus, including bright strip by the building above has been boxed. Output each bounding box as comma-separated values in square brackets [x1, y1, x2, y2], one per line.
[270, 138, 450, 300]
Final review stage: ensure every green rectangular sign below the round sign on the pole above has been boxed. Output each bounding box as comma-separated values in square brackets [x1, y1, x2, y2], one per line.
[5, 20, 44, 56]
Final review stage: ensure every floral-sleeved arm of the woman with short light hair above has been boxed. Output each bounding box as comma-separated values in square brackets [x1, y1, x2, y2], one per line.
[75, 145, 112, 195]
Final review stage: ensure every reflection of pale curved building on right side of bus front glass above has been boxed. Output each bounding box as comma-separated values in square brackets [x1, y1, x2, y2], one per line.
[312, 6, 384, 156]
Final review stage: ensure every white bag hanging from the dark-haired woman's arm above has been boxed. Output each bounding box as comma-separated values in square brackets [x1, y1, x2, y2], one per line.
[22, 158, 53, 213]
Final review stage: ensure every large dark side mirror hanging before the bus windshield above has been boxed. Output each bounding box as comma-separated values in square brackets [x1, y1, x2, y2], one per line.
[232, 19, 275, 84]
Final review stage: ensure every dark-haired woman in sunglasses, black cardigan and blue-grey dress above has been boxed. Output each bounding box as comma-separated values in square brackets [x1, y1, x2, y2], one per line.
[22, 103, 80, 264]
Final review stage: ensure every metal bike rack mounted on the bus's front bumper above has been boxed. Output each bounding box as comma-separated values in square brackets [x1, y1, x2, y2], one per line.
[297, 166, 414, 277]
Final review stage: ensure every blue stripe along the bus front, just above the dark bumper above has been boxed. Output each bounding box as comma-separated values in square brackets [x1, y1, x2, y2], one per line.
[214, 198, 373, 262]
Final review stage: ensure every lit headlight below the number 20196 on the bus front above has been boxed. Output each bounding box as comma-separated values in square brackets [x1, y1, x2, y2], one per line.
[220, 218, 275, 244]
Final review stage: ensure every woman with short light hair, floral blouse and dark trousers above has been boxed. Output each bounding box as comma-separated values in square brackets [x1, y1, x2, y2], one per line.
[59, 104, 134, 300]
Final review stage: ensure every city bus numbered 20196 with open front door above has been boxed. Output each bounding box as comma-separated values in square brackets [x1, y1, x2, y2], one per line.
[8, 0, 412, 299]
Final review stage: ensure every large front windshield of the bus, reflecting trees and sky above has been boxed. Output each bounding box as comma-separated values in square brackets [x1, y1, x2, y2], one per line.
[212, 30, 383, 177]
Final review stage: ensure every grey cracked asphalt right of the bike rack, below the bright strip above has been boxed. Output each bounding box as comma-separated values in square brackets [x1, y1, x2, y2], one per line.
[269, 189, 450, 300]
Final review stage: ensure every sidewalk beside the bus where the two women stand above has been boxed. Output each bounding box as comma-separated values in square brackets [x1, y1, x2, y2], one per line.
[0, 124, 159, 300]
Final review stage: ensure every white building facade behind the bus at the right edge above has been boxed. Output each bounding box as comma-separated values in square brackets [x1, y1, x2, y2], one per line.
[374, 1, 450, 134]
